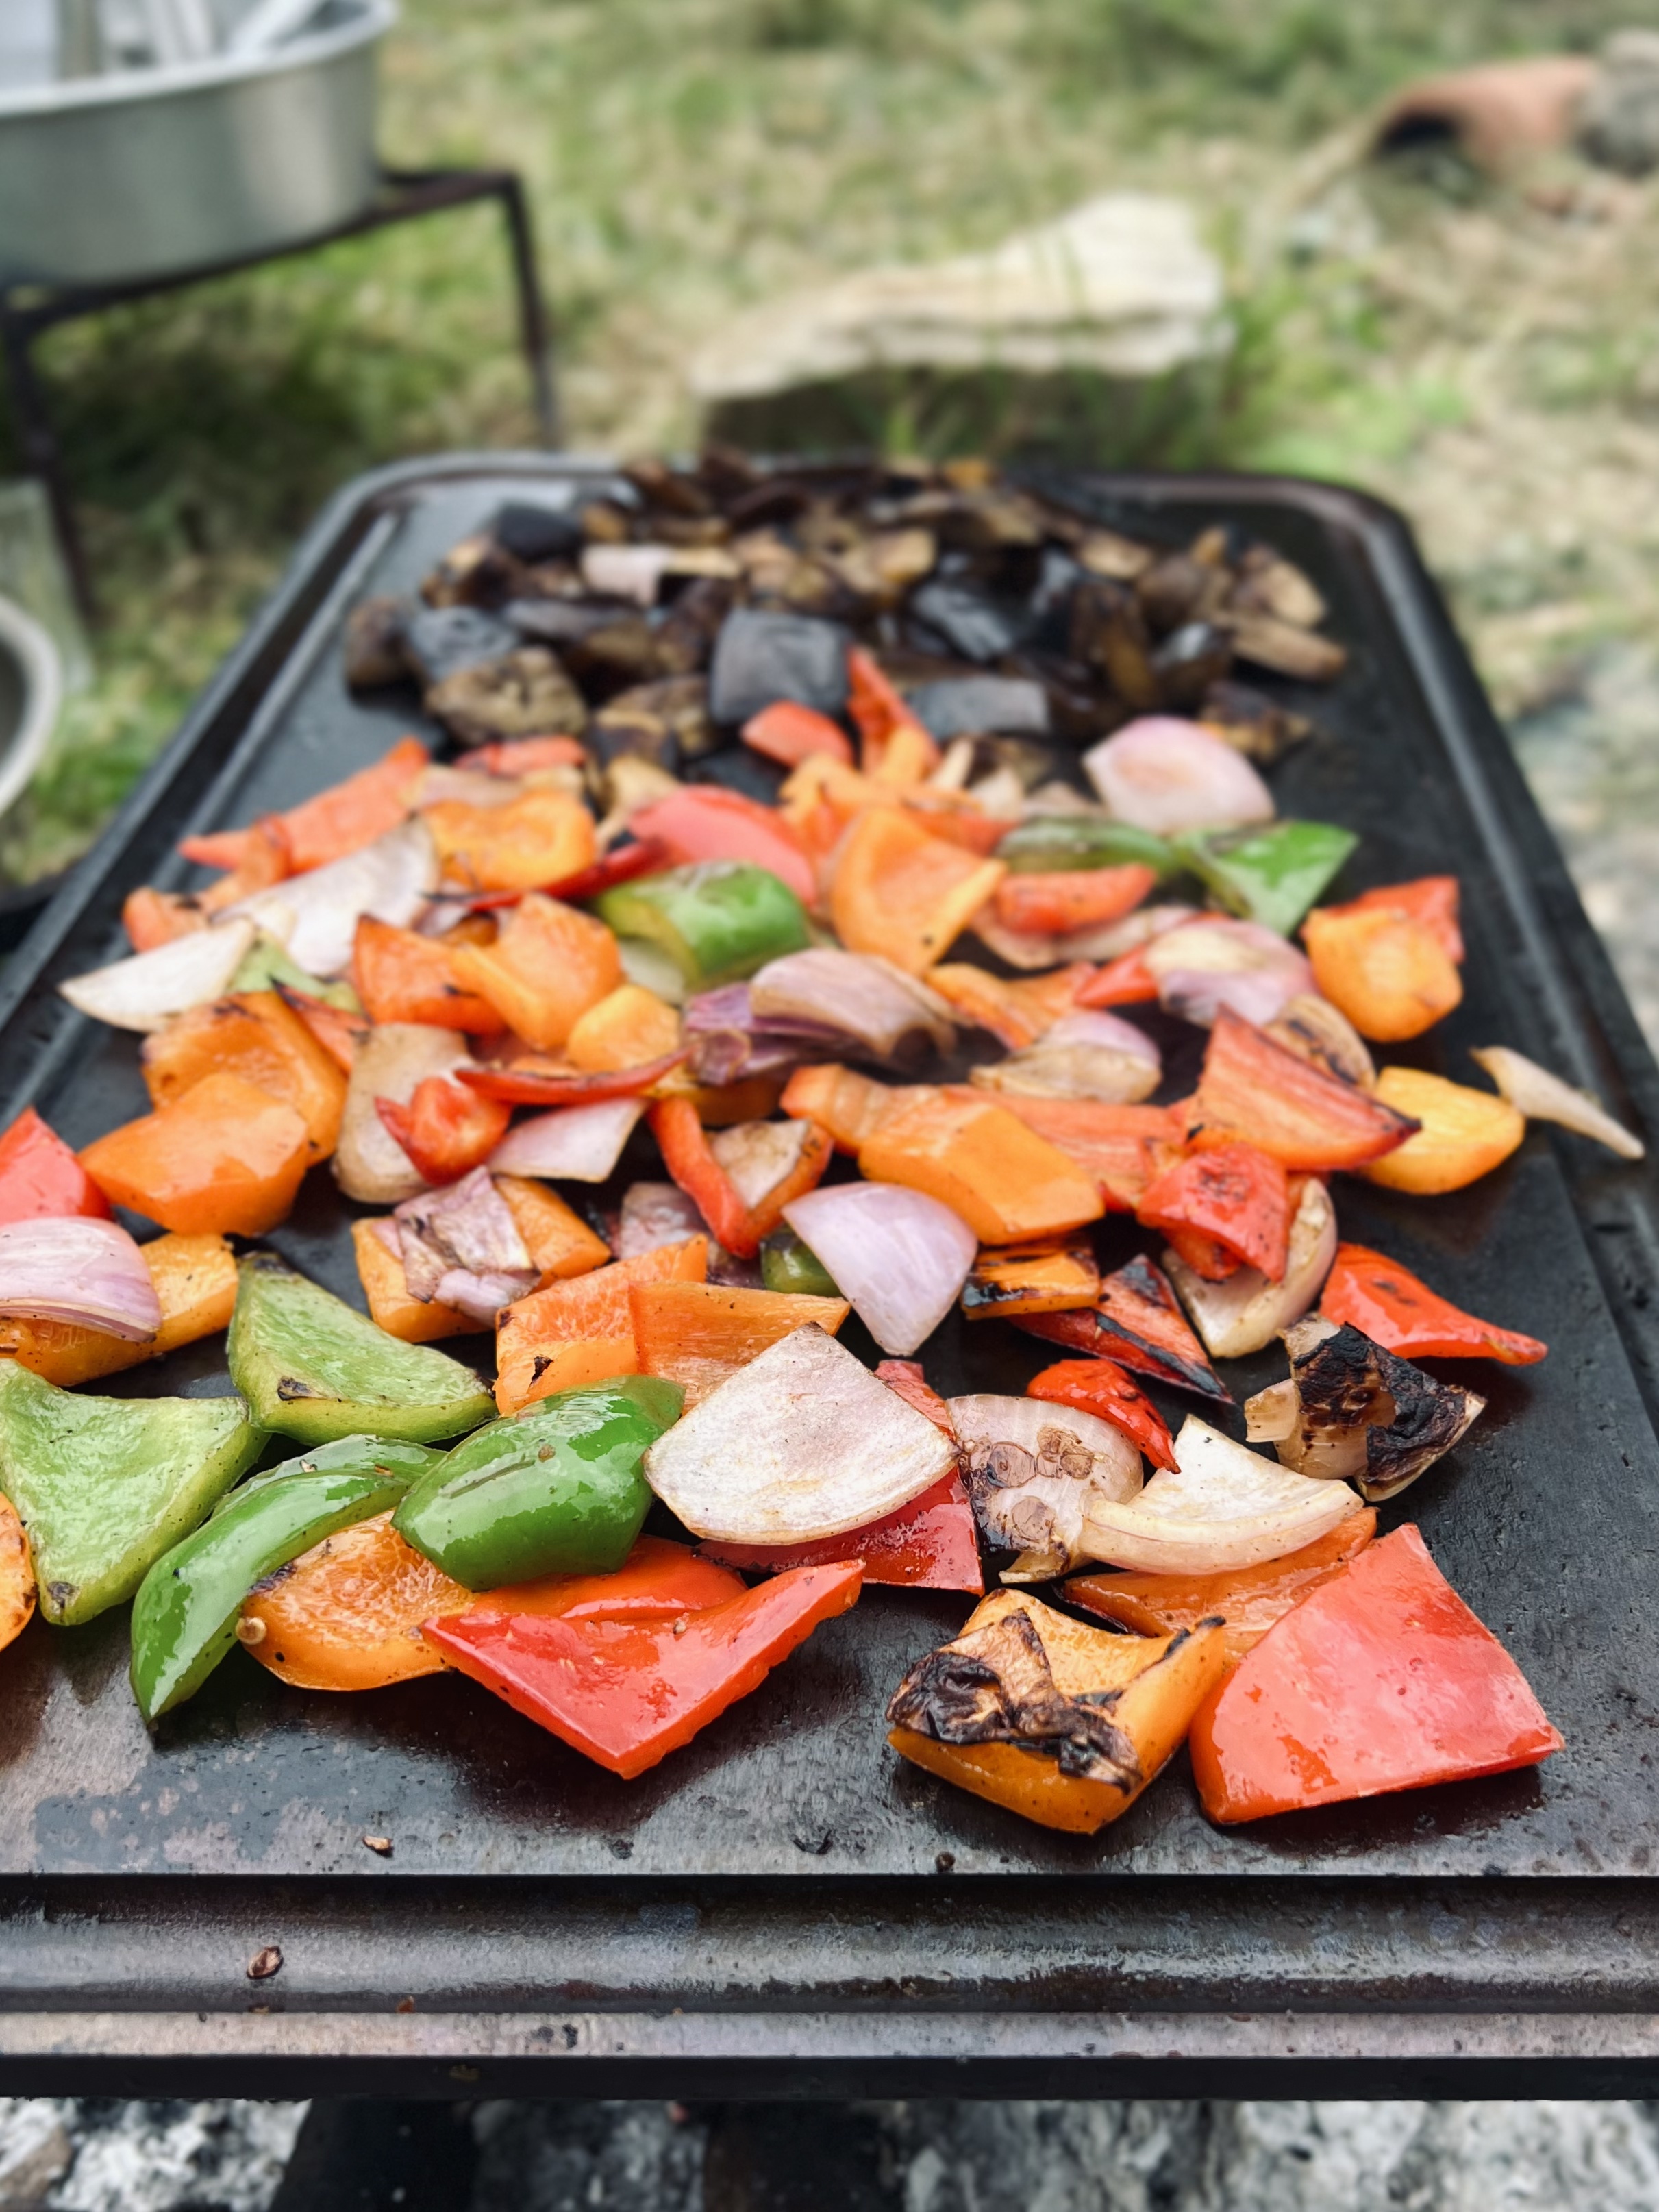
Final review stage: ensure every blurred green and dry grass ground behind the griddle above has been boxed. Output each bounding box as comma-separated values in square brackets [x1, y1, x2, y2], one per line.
[0, 0, 1659, 876]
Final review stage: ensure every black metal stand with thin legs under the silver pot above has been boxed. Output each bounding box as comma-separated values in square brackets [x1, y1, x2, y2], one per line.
[0, 168, 558, 617]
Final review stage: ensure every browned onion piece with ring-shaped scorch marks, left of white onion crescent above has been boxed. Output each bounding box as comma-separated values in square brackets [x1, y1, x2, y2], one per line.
[947, 1395, 1141, 1582]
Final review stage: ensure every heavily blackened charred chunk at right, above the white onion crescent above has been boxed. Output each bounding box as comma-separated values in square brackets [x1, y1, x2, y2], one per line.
[1245, 1316, 1486, 1504]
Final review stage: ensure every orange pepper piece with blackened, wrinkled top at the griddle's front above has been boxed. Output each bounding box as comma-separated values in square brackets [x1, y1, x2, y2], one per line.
[887, 1591, 1225, 1836]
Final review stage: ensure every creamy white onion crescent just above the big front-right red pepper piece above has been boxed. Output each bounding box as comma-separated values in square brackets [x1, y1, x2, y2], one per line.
[1084, 1416, 1360, 1575]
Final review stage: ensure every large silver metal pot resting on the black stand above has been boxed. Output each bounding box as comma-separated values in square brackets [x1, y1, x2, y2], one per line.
[0, 0, 396, 286]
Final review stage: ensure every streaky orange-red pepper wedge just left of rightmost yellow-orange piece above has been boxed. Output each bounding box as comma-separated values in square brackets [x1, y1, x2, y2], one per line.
[1193, 1006, 1422, 1175]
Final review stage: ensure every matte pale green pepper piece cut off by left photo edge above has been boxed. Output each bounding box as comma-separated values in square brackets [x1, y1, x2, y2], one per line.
[0, 1360, 266, 1628]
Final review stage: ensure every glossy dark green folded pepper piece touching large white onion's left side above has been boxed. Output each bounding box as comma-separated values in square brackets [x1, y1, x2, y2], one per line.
[392, 1376, 686, 1591]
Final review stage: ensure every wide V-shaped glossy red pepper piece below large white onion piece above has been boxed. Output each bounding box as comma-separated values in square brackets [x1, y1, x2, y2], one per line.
[421, 1564, 862, 1780]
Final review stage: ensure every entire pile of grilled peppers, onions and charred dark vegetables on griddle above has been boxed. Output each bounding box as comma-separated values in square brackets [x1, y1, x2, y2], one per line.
[0, 453, 1641, 1832]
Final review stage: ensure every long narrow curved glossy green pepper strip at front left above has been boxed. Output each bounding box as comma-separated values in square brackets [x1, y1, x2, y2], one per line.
[131, 1436, 442, 1723]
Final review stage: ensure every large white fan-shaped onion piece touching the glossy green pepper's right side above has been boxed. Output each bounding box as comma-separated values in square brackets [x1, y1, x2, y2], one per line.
[646, 1323, 956, 1544]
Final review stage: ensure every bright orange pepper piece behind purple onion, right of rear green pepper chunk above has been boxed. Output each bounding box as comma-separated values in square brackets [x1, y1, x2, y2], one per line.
[830, 808, 1006, 975]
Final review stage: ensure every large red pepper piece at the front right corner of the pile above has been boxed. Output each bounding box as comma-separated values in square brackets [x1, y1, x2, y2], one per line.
[1193, 1524, 1562, 1823]
